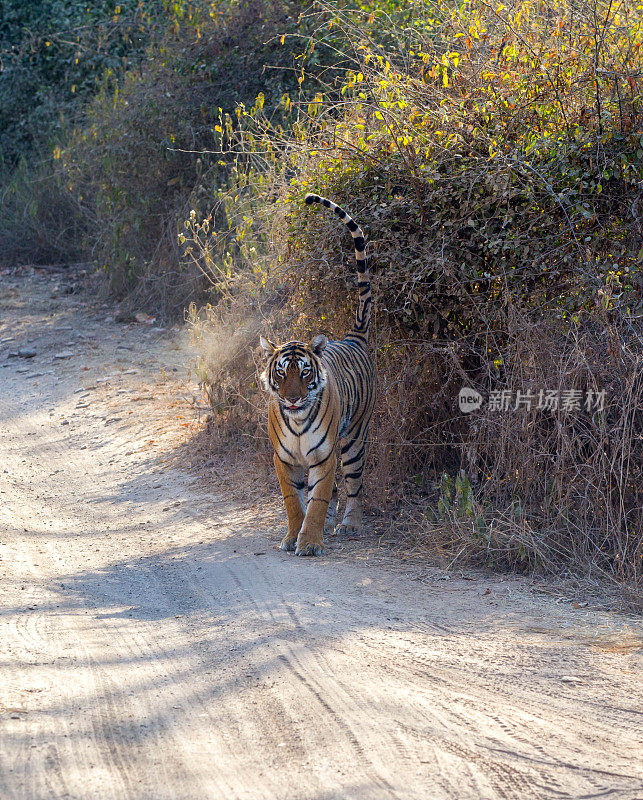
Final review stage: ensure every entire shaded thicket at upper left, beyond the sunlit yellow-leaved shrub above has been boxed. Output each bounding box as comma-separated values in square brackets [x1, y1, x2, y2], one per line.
[0, 0, 322, 294]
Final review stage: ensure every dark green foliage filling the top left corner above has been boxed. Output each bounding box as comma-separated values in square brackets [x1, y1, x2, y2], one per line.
[0, 0, 168, 167]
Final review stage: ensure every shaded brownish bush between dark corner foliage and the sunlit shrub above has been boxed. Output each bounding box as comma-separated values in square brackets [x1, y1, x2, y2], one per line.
[62, 0, 332, 314]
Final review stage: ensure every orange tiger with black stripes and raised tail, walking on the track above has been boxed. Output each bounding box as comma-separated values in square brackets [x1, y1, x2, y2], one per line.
[260, 194, 375, 556]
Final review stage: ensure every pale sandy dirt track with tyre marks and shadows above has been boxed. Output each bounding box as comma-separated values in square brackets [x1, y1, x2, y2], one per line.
[0, 270, 643, 800]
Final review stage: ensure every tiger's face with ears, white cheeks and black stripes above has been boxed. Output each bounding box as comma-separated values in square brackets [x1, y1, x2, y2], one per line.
[261, 334, 328, 416]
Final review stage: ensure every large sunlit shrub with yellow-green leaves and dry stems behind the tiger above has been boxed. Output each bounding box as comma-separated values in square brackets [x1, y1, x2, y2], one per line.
[184, 0, 643, 586]
